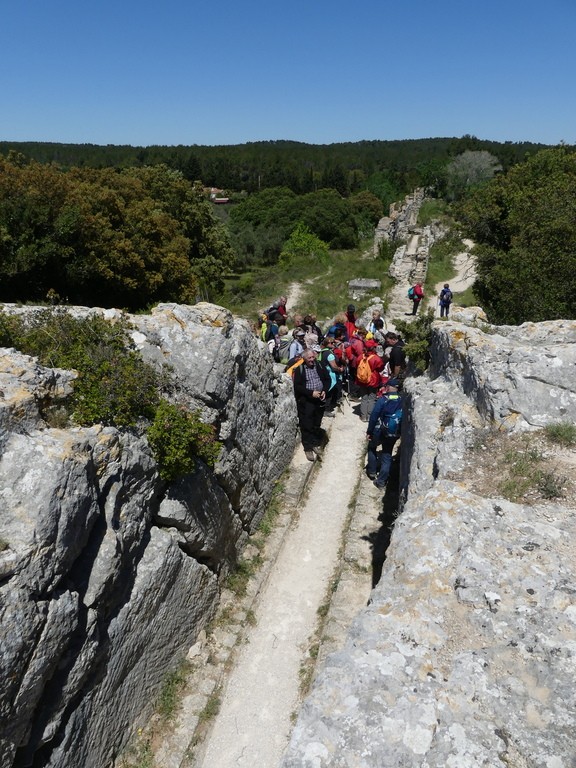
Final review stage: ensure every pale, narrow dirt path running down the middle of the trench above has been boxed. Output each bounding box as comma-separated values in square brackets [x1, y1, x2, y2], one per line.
[195, 405, 378, 768]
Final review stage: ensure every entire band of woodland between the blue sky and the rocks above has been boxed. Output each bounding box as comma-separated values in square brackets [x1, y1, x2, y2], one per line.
[0, 136, 576, 323]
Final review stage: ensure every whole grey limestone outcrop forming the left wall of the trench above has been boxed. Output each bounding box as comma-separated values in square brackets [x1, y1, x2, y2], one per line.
[0, 304, 296, 768]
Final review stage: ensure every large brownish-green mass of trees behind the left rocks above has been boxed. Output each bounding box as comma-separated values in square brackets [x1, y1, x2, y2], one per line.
[0, 156, 234, 309]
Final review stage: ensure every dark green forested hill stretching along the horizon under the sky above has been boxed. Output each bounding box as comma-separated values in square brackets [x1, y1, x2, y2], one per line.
[0, 136, 546, 194]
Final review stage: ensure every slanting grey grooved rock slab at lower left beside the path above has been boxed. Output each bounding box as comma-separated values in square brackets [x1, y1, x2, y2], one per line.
[45, 528, 219, 768]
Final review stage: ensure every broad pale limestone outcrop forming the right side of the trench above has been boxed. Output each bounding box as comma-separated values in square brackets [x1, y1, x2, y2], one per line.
[282, 312, 576, 768]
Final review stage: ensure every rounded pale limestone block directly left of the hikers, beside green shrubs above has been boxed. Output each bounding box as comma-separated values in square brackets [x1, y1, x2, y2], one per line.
[132, 303, 298, 532]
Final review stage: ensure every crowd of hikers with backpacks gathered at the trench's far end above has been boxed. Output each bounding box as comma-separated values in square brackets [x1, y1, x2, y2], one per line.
[260, 296, 406, 488]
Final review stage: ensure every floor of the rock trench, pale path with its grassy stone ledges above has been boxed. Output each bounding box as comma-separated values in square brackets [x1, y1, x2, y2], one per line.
[155, 402, 398, 768]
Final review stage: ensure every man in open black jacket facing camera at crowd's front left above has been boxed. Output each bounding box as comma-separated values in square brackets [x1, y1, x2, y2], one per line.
[294, 349, 331, 461]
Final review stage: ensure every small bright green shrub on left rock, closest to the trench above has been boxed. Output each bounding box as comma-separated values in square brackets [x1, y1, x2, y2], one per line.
[147, 400, 220, 480]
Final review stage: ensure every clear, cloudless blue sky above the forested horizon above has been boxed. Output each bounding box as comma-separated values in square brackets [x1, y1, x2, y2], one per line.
[0, 0, 576, 146]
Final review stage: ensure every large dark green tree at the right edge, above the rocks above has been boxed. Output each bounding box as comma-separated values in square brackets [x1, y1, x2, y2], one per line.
[457, 147, 576, 324]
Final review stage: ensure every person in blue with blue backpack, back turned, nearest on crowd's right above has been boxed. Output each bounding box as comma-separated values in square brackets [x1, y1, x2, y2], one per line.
[366, 379, 403, 489]
